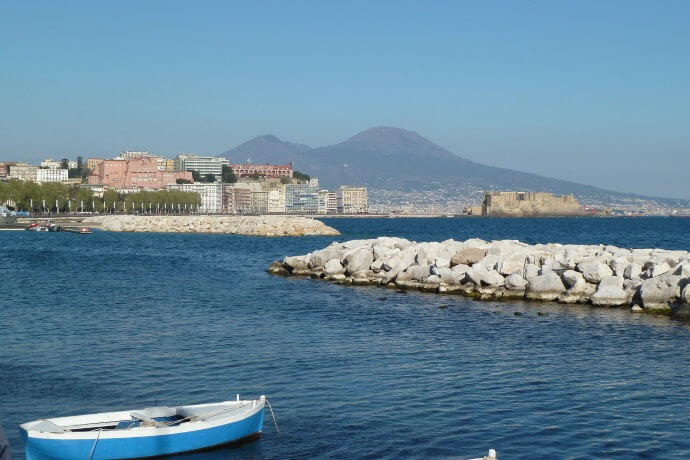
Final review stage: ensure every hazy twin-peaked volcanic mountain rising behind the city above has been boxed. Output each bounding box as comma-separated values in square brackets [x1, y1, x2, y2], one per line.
[221, 126, 676, 201]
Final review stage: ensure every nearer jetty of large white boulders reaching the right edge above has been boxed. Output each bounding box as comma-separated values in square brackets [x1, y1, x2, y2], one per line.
[268, 237, 690, 315]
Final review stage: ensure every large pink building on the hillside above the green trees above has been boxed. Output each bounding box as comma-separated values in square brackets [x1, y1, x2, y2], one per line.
[87, 157, 194, 189]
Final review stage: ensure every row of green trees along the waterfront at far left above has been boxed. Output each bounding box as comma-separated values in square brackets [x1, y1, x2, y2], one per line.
[0, 180, 201, 213]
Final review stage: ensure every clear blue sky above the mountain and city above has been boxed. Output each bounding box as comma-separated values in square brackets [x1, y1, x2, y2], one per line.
[0, 0, 690, 199]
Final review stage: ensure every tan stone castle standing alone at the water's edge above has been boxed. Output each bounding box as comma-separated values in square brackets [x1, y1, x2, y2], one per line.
[471, 191, 582, 217]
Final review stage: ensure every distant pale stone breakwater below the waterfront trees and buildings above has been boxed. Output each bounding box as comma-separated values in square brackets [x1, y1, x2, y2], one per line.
[88, 215, 340, 236]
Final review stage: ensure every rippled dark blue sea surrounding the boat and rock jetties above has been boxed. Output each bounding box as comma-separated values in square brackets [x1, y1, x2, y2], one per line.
[0, 218, 690, 459]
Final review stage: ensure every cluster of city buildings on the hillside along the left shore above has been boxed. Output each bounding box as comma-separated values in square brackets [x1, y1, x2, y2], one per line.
[0, 151, 369, 215]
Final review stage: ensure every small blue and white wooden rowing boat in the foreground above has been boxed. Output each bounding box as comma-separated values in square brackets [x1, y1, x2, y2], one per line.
[20, 395, 266, 460]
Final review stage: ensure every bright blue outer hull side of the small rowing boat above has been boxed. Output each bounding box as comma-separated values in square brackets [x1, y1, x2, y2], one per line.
[21, 409, 264, 460]
